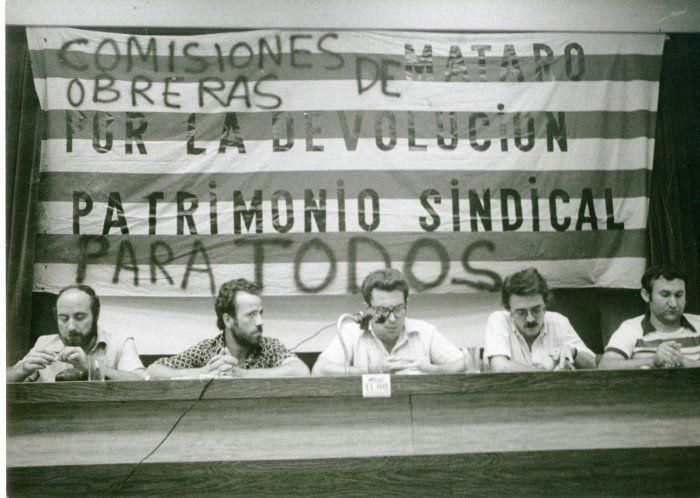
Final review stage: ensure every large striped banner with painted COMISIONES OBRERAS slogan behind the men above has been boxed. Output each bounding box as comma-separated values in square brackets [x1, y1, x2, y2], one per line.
[27, 28, 663, 296]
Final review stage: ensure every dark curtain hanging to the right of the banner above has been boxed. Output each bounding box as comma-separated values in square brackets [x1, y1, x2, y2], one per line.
[648, 34, 700, 313]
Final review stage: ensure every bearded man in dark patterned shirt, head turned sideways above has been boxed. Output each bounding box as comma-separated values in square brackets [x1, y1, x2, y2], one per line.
[148, 278, 309, 379]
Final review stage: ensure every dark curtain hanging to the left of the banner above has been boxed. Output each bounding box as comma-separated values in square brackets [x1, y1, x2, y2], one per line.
[5, 26, 43, 364]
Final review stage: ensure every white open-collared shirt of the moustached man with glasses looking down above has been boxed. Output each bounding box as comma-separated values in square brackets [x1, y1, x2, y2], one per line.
[484, 310, 595, 368]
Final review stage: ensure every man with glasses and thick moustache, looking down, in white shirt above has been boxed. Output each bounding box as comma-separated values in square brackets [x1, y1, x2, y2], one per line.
[484, 268, 596, 372]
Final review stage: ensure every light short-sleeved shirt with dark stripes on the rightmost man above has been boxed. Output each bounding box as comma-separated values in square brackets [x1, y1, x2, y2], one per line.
[605, 313, 700, 360]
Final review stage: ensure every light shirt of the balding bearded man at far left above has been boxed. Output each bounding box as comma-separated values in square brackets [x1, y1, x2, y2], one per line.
[21, 328, 143, 382]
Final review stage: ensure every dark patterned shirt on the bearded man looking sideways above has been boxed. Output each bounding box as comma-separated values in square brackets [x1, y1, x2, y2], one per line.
[156, 334, 294, 368]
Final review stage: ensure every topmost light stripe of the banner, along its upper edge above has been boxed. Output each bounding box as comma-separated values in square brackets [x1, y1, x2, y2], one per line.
[27, 27, 664, 57]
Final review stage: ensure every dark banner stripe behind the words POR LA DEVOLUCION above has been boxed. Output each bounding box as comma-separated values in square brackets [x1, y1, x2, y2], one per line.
[46, 106, 656, 140]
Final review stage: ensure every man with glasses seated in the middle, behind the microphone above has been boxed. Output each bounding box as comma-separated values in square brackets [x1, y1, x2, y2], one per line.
[312, 269, 464, 375]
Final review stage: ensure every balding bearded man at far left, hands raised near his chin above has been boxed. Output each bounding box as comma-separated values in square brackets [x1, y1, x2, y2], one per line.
[7, 284, 147, 382]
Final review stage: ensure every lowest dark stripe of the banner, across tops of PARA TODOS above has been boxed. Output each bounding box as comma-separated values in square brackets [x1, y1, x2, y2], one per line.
[35, 230, 646, 265]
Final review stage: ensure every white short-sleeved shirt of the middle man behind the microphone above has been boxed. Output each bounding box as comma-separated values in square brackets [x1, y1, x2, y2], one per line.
[319, 318, 462, 373]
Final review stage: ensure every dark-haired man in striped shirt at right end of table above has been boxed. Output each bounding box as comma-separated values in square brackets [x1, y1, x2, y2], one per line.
[600, 267, 700, 370]
